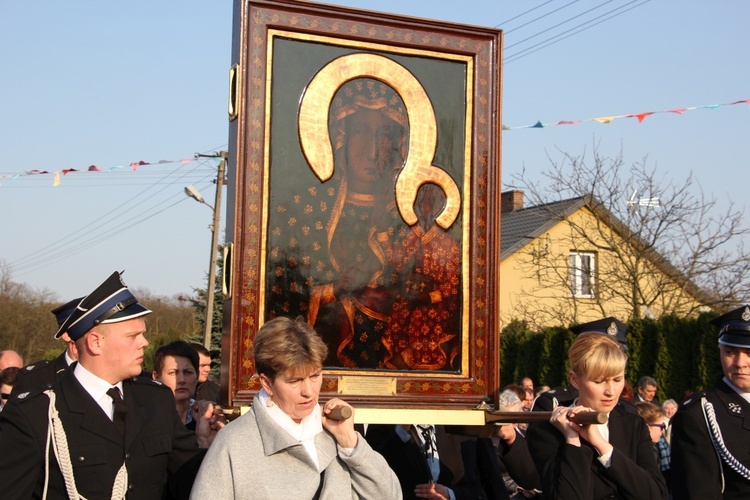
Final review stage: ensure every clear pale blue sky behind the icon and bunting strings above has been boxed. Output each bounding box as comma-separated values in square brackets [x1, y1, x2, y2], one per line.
[0, 0, 750, 301]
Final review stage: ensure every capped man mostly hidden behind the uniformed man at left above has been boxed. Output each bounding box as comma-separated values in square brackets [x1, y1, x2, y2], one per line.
[11, 297, 83, 396]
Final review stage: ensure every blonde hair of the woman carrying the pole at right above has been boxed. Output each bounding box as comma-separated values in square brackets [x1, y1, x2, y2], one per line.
[568, 332, 628, 379]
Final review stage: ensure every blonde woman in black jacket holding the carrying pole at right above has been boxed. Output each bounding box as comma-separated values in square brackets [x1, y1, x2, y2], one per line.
[526, 333, 667, 500]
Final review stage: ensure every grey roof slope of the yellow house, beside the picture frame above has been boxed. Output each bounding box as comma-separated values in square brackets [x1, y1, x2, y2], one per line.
[500, 197, 587, 262]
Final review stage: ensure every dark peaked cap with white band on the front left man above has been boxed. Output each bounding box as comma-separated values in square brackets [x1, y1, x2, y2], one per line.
[55, 271, 151, 340]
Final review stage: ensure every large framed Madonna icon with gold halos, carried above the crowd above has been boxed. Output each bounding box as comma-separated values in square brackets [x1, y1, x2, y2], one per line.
[222, 0, 501, 408]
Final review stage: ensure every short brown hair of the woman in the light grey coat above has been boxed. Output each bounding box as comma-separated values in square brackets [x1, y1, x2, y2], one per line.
[253, 316, 328, 380]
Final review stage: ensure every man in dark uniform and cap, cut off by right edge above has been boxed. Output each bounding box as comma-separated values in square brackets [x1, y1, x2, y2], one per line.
[671, 305, 750, 500]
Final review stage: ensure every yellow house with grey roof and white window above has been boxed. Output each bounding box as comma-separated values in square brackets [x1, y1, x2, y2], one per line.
[500, 191, 707, 328]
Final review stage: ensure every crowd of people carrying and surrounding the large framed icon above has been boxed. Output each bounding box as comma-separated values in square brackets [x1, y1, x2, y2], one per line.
[0, 273, 750, 500]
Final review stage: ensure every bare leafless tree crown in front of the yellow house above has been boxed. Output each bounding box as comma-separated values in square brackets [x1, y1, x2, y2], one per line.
[508, 143, 750, 328]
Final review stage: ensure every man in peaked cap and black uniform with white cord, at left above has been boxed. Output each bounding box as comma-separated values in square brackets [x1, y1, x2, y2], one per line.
[0, 272, 215, 500]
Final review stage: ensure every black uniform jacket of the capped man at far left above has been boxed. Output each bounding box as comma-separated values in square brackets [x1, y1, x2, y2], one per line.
[0, 369, 203, 500]
